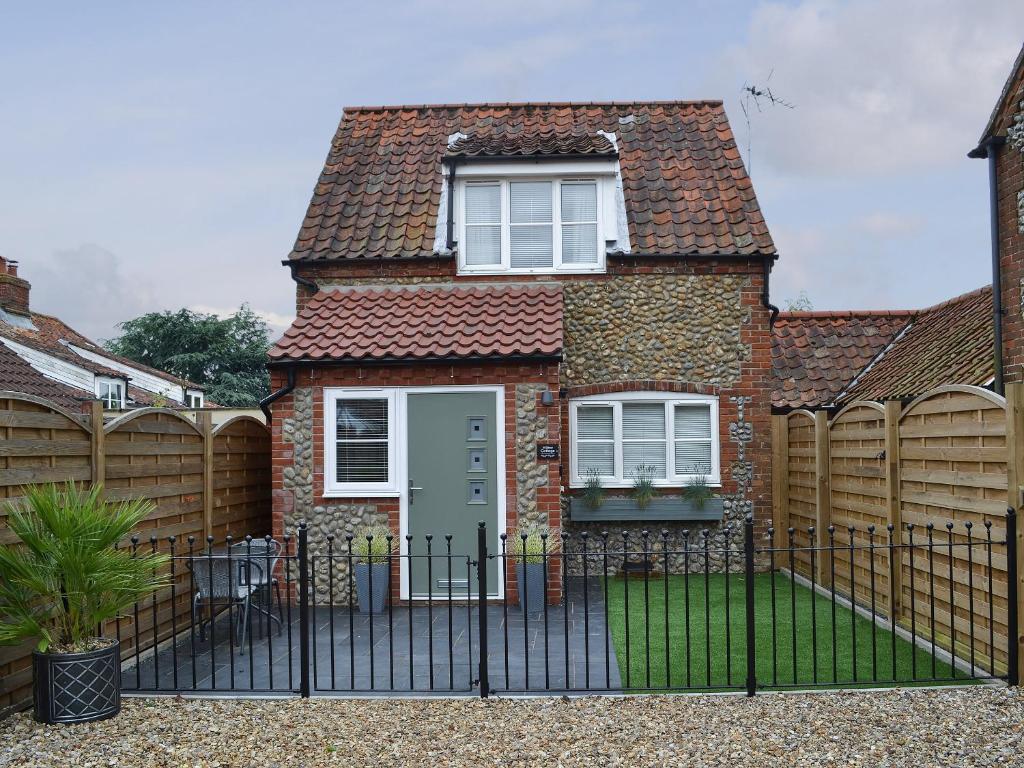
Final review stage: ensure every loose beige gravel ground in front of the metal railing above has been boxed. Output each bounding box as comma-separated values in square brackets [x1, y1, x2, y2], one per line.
[0, 687, 1024, 768]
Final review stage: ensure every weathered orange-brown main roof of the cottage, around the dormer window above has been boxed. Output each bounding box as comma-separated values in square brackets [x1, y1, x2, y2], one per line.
[290, 101, 775, 261]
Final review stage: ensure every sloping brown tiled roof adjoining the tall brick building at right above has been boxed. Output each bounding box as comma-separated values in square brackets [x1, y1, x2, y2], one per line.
[842, 286, 995, 401]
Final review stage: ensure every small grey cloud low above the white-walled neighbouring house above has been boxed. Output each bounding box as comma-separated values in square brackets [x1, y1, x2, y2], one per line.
[22, 243, 158, 341]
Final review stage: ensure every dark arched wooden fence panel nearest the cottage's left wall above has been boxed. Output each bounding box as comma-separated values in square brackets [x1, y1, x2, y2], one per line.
[213, 416, 271, 541]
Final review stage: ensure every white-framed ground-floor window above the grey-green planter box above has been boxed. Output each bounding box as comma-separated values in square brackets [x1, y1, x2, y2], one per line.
[569, 392, 721, 487]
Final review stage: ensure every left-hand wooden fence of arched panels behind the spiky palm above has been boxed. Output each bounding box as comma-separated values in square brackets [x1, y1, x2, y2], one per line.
[0, 391, 271, 717]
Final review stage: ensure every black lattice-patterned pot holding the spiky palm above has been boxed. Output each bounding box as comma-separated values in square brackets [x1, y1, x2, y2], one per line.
[32, 642, 121, 723]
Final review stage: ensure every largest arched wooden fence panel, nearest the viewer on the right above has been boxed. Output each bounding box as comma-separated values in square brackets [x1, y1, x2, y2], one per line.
[899, 386, 1008, 667]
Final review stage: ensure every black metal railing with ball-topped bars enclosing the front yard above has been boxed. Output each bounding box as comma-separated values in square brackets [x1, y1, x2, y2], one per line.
[116, 510, 1019, 696]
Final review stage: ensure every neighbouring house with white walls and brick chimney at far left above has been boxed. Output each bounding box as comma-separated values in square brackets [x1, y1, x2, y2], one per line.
[0, 256, 206, 414]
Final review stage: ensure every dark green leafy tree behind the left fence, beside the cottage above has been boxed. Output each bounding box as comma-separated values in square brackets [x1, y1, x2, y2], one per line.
[105, 304, 270, 408]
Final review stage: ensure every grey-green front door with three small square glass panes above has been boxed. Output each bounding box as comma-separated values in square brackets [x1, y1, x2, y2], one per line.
[402, 392, 503, 599]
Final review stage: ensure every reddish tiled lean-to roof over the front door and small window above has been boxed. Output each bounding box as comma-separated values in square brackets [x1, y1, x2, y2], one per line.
[270, 285, 562, 362]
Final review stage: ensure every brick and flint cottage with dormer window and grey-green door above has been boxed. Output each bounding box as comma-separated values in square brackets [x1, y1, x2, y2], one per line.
[265, 101, 776, 595]
